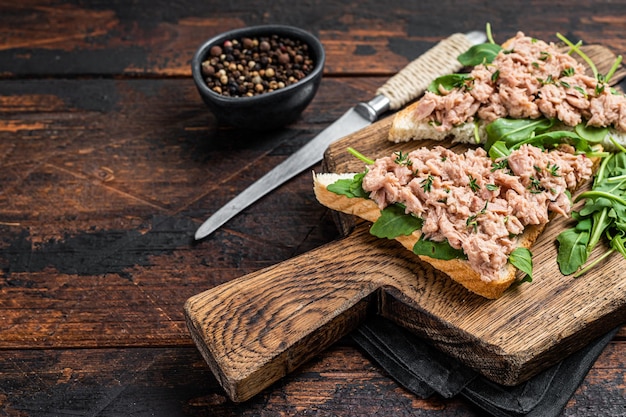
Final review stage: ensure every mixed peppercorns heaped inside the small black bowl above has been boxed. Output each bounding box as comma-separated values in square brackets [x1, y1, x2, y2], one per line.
[202, 35, 314, 97]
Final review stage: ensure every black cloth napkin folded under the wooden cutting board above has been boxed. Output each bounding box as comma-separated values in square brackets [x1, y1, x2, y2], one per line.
[352, 316, 618, 417]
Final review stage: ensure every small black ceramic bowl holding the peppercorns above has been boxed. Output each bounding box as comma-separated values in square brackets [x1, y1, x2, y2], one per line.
[191, 25, 326, 130]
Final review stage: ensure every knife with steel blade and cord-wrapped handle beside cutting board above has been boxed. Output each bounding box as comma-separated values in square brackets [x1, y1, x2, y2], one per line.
[195, 31, 487, 240]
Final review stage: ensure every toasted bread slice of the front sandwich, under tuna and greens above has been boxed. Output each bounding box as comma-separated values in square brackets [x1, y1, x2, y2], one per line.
[313, 173, 545, 299]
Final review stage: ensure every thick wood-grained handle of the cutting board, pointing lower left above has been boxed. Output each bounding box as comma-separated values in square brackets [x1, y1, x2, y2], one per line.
[185, 232, 401, 402]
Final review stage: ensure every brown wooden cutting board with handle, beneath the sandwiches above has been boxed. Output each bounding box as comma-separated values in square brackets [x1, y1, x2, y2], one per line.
[184, 46, 626, 401]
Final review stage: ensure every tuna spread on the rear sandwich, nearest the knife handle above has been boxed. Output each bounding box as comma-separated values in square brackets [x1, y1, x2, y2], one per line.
[415, 32, 626, 131]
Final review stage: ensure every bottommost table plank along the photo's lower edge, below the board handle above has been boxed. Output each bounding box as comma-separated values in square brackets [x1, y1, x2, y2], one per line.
[0, 340, 626, 417]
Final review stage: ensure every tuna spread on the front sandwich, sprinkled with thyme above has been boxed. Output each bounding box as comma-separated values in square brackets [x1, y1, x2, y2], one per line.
[363, 145, 592, 281]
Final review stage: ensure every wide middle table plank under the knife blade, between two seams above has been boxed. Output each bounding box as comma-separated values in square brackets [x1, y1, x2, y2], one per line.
[0, 78, 386, 348]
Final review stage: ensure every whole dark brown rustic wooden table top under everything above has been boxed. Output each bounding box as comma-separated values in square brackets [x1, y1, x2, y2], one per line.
[0, 0, 626, 417]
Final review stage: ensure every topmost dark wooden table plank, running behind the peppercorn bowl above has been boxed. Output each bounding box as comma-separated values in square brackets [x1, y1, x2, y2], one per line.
[0, 0, 626, 77]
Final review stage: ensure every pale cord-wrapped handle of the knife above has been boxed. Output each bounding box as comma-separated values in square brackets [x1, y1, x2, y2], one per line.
[376, 32, 482, 110]
